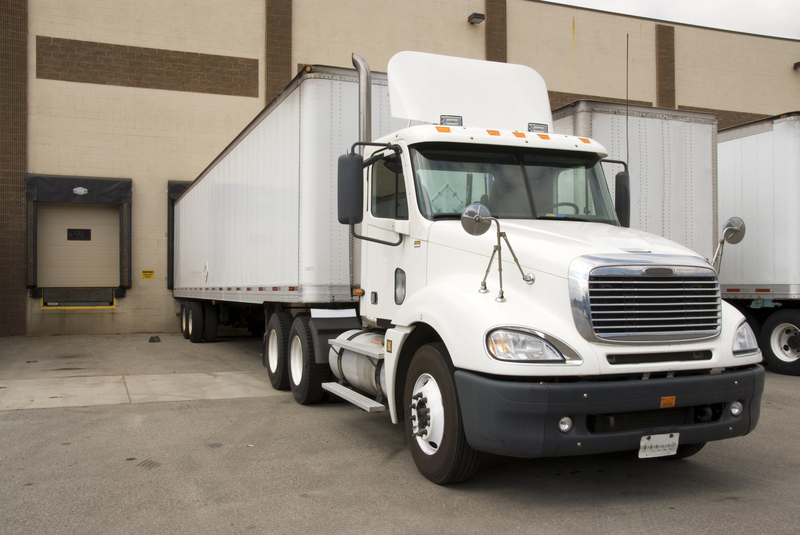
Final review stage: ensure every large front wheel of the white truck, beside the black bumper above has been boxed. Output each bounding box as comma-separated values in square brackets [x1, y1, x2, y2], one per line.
[403, 343, 478, 485]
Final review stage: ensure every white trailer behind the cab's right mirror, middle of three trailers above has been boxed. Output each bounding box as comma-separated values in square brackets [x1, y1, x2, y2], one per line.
[553, 100, 719, 259]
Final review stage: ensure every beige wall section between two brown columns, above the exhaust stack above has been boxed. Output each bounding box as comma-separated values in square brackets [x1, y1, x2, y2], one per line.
[292, 0, 486, 72]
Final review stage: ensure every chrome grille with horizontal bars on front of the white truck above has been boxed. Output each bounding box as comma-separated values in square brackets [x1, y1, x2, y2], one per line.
[588, 274, 721, 339]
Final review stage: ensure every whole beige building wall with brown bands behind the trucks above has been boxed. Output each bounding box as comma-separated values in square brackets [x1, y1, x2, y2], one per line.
[17, 0, 800, 334]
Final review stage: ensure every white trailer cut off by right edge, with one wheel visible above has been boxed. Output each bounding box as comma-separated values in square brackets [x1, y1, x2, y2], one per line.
[718, 112, 800, 375]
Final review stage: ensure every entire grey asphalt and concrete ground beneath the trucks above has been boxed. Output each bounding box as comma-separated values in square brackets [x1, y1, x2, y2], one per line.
[0, 333, 800, 535]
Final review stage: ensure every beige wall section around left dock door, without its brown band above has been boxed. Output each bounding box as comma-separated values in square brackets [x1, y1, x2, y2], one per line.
[28, 0, 265, 334]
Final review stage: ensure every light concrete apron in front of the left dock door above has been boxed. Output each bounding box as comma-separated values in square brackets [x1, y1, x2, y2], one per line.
[0, 331, 278, 410]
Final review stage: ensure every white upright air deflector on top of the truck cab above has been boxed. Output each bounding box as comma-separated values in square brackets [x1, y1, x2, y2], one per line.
[387, 52, 553, 132]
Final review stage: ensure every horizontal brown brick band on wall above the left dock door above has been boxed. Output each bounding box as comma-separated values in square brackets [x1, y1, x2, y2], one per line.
[36, 35, 259, 97]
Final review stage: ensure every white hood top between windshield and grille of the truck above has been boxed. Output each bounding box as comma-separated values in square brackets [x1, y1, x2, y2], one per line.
[429, 219, 700, 278]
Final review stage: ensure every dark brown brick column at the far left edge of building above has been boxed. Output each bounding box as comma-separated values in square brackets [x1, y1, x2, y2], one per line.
[0, 0, 28, 336]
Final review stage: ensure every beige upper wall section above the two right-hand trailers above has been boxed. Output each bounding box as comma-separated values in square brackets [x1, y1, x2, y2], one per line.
[508, 0, 800, 122]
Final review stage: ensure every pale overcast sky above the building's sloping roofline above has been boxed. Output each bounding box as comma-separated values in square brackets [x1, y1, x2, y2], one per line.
[545, 0, 800, 39]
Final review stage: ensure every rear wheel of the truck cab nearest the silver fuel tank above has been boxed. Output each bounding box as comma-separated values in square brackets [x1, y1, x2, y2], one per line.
[286, 316, 328, 405]
